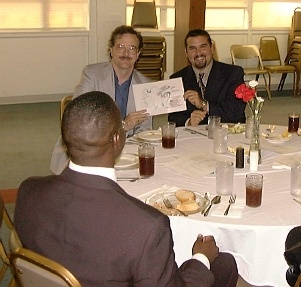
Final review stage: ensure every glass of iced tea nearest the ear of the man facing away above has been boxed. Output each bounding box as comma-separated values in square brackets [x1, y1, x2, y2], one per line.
[138, 143, 155, 177]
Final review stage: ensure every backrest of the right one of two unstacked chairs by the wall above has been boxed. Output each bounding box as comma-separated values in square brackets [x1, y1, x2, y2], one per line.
[259, 36, 281, 65]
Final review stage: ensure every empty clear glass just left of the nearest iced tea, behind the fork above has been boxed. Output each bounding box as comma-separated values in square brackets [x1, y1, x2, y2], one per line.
[215, 161, 234, 195]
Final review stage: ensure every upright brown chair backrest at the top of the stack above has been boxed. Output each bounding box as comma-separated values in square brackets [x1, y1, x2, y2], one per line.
[131, 0, 158, 29]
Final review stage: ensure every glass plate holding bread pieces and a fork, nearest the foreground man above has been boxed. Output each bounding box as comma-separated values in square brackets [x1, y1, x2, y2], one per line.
[145, 191, 210, 216]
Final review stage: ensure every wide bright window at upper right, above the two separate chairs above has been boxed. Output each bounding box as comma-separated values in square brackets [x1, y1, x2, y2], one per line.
[205, 0, 301, 30]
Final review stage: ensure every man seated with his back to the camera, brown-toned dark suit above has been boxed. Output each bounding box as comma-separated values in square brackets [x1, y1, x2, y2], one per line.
[15, 91, 238, 287]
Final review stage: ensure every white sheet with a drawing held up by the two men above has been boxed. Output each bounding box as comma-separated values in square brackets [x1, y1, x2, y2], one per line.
[133, 78, 186, 116]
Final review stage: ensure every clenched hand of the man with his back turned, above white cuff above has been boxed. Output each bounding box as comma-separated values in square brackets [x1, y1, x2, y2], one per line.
[192, 236, 218, 263]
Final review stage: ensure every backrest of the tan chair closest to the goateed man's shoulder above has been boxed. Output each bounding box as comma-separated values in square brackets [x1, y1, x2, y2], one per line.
[230, 45, 263, 70]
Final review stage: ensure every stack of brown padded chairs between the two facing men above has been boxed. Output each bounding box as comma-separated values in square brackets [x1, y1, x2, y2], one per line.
[131, 0, 166, 81]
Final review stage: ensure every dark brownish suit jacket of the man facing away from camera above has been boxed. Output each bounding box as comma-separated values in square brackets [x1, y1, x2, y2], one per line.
[15, 168, 214, 287]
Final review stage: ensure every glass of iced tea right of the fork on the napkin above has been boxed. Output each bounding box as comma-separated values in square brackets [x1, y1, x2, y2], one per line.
[246, 173, 263, 207]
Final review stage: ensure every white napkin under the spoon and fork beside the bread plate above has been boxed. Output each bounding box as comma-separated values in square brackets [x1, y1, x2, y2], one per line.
[210, 196, 246, 218]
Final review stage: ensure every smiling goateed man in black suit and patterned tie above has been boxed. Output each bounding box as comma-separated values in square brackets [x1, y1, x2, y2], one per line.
[168, 29, 246, 126]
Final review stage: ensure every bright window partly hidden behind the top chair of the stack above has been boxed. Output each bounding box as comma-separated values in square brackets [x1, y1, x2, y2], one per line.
[126, 0, 175, 30]
